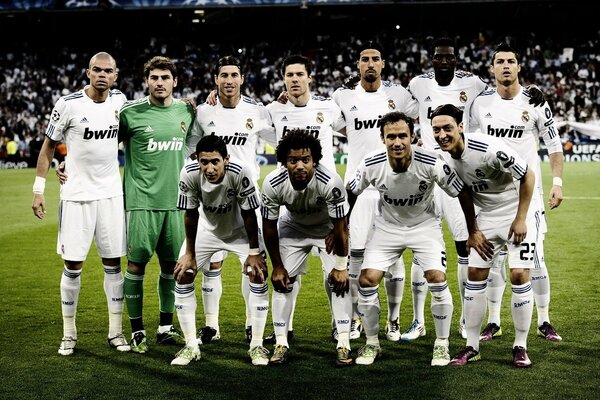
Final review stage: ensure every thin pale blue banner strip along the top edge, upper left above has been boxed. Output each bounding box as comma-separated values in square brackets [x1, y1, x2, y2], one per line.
[0, 0, 392, 11]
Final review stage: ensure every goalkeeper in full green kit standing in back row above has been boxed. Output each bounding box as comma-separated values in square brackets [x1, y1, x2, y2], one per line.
[119, 56, 194, 353]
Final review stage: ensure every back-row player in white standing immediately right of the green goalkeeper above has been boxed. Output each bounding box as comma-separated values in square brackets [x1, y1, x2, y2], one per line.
[189, 56, 276, 344]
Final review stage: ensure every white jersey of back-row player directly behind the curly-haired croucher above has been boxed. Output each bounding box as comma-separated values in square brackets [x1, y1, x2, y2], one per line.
[266, 96, 346, 171]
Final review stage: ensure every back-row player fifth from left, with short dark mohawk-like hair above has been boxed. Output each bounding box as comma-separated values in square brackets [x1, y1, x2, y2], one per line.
[333, 41, 418, 341]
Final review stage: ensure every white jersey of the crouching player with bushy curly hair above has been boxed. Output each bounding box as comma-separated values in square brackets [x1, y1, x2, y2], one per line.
[261, 165, 350, 238]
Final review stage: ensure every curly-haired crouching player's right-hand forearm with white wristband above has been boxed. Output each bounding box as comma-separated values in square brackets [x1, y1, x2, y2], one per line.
[327, 217, 350, 297]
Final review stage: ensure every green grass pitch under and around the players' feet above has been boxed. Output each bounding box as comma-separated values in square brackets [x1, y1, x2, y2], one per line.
[0, 163, 600, 400]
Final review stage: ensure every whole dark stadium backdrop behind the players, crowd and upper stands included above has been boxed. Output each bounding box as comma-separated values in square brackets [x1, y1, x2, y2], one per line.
[0, 0, 600, 168]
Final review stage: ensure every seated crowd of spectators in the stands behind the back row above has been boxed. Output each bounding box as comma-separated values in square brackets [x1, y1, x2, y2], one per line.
[0, 28, 600, 166]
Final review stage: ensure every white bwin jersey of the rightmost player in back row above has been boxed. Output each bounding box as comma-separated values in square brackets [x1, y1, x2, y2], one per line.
[465, 88, 562, 195]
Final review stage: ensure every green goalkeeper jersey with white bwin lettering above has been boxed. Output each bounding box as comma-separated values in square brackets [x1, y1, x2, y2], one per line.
[119, 97, 194, 211]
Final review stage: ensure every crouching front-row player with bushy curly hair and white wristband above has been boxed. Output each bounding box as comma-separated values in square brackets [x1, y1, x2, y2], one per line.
[261, 129, 353, 366]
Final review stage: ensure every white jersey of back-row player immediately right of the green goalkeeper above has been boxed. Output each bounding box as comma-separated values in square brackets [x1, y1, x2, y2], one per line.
[186, 96, 276, 183]
